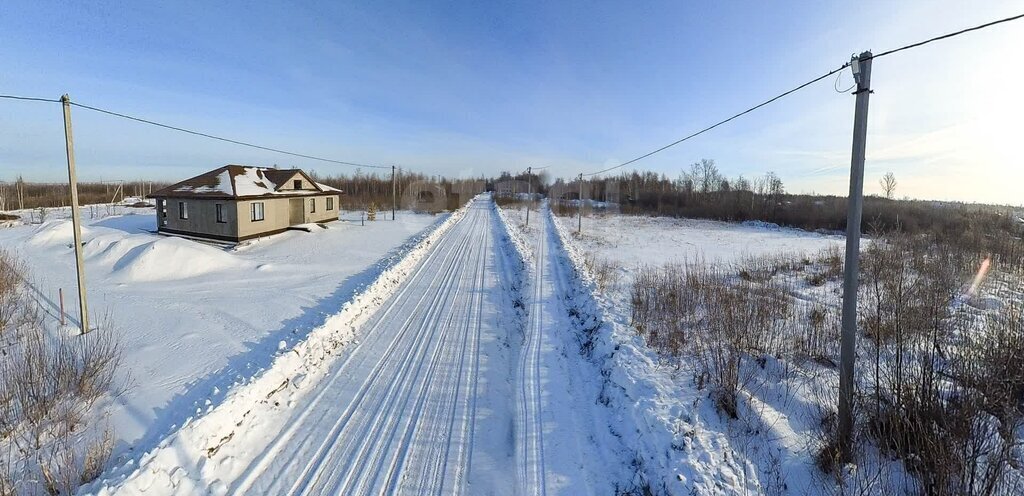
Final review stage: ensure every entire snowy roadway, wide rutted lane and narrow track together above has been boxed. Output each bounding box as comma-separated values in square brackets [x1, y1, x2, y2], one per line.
[100, 198, 629, 495]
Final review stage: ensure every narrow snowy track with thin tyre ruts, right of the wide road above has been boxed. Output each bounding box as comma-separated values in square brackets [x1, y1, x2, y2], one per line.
[515, 208, 629, 495]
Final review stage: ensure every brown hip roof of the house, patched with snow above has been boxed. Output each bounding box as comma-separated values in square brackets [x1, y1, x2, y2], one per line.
[150, 165, 341, 199]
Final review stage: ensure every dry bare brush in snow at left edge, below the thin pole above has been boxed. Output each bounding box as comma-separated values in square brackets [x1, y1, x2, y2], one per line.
[0, 252, 125, 495]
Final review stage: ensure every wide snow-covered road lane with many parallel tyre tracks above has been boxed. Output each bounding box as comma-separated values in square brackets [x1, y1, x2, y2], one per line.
[232, 198, 509, 494]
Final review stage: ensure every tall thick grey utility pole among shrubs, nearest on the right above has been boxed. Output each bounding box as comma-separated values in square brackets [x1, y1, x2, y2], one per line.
[839, 51, 871, 460]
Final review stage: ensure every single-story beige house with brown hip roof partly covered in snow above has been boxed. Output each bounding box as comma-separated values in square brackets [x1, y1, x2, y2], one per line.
[150, 165, 341, 242]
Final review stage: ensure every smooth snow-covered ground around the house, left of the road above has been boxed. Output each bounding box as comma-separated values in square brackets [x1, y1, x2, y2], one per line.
[0, 206, 444, 460]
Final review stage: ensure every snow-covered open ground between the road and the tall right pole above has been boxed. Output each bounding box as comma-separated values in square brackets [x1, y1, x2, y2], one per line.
[540, 212, 845, 494]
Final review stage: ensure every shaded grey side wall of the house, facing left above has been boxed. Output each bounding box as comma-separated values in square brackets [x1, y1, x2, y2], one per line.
[157, 198, 238, 238]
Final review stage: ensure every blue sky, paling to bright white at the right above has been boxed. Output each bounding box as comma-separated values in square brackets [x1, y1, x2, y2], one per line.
[0, 0, 1024, 204]
